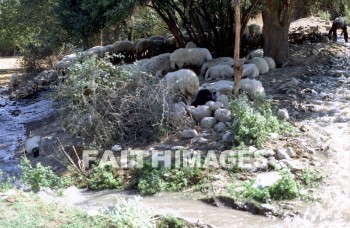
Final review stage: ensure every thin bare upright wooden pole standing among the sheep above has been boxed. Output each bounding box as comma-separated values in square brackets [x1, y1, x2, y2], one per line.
[233, 0, 243, 97]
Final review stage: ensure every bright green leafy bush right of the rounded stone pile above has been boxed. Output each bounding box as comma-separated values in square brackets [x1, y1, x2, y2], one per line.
[230, 96, 292, 147]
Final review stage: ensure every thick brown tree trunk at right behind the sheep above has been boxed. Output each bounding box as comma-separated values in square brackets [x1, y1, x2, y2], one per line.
[262, 0, 294, 67]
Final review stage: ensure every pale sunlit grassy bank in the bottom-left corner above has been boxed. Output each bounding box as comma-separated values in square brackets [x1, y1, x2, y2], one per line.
[0, 192, 113, 228]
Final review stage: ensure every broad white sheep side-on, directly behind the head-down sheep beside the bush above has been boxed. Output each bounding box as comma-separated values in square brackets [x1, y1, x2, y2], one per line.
[170, 48, 212, 69]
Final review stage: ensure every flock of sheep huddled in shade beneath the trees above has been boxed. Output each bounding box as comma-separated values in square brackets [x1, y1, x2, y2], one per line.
[55, 23, 270, 104]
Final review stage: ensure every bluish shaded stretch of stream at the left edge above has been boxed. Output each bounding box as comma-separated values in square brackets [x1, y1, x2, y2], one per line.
[0, 87, 54, 176]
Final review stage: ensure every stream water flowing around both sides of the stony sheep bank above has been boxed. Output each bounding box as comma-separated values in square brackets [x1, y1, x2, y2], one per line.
[0, 41, 350, 227]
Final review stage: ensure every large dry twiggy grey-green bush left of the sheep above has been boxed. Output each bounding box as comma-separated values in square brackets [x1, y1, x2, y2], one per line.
[56, 56, 183, 147]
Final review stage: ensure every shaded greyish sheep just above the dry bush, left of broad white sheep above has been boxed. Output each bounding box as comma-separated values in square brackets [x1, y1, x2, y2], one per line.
[142, 53, 171, 76]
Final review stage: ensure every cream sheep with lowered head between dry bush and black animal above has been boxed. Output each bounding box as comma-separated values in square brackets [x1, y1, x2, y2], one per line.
[164, 69, 199, 105]
